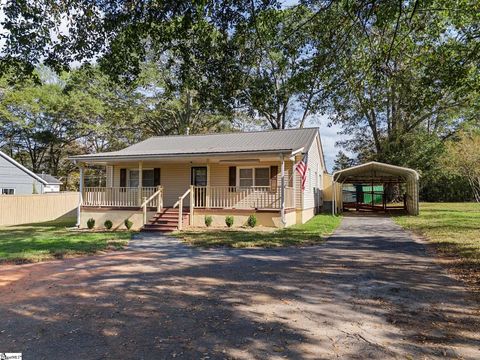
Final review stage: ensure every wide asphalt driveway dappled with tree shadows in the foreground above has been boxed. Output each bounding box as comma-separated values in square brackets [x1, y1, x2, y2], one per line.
[0, 217, 480, 359]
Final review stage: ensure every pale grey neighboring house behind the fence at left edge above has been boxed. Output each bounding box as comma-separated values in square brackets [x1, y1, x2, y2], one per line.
[0, 151, 62, 195]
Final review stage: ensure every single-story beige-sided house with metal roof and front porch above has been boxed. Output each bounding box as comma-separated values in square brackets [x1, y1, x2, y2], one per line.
[71, 128, 327, 231]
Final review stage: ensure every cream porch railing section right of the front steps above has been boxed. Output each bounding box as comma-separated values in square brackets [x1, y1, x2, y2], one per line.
[193, 186, 295, 209]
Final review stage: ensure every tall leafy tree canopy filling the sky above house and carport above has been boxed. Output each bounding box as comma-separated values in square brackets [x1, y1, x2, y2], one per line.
[0, 0, 480, 197]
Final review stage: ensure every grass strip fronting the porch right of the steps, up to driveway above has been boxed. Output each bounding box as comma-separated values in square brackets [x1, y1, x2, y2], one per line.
[175, 215, 341, 248]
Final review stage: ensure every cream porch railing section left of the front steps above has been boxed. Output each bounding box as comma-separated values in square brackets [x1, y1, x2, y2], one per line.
[82, 186, 159, 207]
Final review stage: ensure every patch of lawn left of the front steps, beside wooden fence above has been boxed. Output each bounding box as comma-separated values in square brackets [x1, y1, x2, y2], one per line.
[0, 219, 131, 263]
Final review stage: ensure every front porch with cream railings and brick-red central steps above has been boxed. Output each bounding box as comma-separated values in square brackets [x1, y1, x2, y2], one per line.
[82, 185, 295, 231]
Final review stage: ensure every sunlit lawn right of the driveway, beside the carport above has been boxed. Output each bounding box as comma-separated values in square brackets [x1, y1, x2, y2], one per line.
[394, 203, 480, 287]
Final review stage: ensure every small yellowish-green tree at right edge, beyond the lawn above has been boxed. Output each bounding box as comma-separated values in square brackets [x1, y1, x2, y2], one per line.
[443, 130, 480, 202]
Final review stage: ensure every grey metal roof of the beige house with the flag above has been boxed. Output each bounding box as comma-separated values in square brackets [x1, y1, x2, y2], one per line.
[71, 128, 318, 160]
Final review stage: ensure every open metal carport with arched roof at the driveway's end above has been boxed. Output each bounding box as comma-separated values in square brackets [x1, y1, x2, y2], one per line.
[332, 161, 420, 215]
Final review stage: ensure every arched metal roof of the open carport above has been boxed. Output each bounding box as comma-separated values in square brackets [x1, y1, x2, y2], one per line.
[333, 161, 420, 184]
